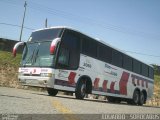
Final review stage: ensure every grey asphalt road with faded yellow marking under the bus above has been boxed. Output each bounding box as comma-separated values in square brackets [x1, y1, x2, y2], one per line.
[0, 87, 160, 114]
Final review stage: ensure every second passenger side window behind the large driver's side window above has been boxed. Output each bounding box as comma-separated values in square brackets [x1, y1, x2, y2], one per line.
[98, 44, 112, 63]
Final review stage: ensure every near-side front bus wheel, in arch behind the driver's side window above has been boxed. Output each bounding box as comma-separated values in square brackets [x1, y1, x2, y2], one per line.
[75, 80, 86, 99]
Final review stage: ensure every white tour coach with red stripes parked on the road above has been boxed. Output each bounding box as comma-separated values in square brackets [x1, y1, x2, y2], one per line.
[13, 27, 154, 105]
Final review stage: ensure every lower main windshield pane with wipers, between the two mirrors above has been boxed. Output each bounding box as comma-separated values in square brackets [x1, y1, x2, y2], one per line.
[21, 41, 54, 67]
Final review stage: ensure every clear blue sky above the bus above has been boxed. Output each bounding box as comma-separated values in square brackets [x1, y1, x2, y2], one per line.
[0, 0, 160, 65]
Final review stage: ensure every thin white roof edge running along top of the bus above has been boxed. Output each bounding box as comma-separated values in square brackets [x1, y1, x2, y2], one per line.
[33, 26, 153, 68]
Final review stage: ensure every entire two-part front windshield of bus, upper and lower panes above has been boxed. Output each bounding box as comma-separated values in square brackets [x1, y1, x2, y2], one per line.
[21, 28, 62, 67]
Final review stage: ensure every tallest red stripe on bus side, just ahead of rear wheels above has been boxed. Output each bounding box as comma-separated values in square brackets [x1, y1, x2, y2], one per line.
[119, 72, 129, 95]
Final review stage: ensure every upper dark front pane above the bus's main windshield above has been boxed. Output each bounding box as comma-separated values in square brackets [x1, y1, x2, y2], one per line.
[29, 28, 62, 41]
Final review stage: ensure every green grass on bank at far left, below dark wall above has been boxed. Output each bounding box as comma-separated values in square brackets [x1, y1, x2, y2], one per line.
[0, 51, 21, 67]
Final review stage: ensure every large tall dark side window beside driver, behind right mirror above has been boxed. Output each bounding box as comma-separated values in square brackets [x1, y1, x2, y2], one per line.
[58, 31, 80, 69]
